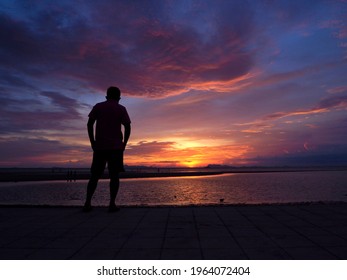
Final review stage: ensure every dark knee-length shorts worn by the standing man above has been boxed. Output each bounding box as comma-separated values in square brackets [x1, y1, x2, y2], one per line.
[90, 150, 125, 178]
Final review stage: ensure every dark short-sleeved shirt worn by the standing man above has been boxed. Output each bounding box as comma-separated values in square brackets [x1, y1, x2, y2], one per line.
[88, 99, 131, 150]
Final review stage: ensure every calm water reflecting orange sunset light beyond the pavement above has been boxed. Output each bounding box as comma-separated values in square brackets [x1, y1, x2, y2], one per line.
[0, 171, 347, 206]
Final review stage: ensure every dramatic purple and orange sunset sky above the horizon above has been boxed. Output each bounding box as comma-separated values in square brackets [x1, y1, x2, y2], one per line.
[0, 0, 347, 167]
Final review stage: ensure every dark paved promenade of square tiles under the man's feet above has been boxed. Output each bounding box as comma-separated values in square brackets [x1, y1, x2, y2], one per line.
[0, 203, 347, 260]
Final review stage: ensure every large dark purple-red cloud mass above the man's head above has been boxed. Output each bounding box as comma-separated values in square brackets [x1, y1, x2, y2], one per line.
[0, 2, 253, 97]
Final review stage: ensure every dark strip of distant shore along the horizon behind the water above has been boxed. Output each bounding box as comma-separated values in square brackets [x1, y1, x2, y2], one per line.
[0, 166, 347, 182]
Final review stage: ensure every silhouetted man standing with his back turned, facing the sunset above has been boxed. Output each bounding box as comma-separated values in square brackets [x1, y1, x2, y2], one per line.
[83, 87, 131, 212]
